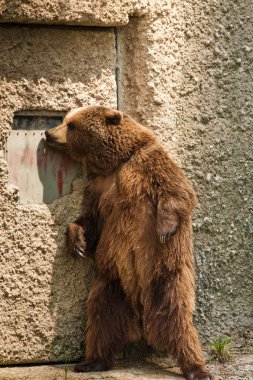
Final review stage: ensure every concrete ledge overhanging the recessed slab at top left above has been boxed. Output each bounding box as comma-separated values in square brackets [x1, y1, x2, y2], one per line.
[0, 0, 148, 26]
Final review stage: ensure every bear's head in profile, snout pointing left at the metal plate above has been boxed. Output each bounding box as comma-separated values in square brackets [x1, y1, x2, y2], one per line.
[45, 106, 155, 175]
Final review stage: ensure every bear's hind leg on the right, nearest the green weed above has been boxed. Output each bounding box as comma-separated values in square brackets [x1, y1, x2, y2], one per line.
[144, 271, 213, 380]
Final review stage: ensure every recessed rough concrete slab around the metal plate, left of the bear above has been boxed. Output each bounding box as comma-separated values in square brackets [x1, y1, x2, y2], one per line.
[0, 27, 116, 363]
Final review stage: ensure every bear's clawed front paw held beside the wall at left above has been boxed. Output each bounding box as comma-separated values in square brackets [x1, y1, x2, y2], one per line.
[66, 223, 86, 258]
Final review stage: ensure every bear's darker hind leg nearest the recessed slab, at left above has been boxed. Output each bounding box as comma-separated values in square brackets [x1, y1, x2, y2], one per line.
[75, 278, 140, 372]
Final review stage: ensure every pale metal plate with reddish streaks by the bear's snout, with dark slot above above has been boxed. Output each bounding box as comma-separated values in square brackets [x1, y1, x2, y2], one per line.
[6, 115, 80, 203]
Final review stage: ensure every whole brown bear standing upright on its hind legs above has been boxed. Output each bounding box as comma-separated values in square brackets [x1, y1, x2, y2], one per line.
[46, 106, 213, 380]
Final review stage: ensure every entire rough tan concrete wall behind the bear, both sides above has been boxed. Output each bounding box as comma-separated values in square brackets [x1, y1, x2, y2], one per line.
[0, 0, 253, 362]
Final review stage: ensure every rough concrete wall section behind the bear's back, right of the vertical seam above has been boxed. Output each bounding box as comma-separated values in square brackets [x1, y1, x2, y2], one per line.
[118, 0, 253, 344]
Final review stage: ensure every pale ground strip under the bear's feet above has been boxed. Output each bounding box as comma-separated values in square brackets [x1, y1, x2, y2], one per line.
[0, 354, 253, 380]
